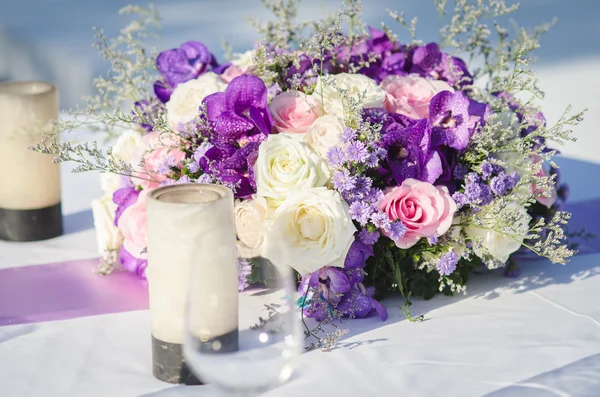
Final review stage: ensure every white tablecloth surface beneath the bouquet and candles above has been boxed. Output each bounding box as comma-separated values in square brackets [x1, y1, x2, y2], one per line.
[0, 126, 600, 397]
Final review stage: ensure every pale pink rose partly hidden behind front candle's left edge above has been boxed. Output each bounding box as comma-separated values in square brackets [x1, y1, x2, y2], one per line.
[117, 190, 148, 259]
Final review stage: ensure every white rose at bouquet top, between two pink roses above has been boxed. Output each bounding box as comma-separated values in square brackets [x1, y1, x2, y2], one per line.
[314, 73, 385, 119]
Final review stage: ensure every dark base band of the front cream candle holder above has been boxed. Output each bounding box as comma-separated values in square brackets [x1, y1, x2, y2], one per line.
[152, 329, 238, 385]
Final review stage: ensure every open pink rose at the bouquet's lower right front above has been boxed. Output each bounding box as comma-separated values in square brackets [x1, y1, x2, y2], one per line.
[377, 179, 456, 249]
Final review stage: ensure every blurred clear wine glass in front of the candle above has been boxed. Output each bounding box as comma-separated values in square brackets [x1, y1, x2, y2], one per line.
[184, 251, 302, 395]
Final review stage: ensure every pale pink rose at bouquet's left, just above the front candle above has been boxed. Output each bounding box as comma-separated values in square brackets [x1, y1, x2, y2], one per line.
[132, 131, 185, 190]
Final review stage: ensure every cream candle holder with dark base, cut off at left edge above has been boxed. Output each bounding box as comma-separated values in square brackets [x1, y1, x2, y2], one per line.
[0, 81, 62, 241]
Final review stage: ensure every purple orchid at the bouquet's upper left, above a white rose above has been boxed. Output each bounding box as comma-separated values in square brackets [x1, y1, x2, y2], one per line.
[154, 41, 217, 103]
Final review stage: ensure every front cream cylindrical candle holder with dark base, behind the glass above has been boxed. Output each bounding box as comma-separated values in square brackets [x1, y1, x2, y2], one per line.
[147, 184, 238, 384]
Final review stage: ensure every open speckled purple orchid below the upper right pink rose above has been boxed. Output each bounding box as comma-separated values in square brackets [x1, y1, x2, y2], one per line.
[429, 91, 491, 150]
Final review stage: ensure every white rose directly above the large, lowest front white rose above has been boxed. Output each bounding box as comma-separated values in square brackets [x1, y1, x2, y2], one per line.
[254, 134, 329, 202]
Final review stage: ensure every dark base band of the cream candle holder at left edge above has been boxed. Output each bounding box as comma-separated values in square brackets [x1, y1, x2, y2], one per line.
[0, 203, 63, 241]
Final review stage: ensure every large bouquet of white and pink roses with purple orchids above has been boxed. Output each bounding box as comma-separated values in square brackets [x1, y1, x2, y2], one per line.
[37, 0, 581, 344]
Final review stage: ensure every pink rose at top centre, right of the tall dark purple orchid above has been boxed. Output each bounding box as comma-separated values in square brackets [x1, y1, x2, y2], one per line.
[269, 91, 319, 134]
